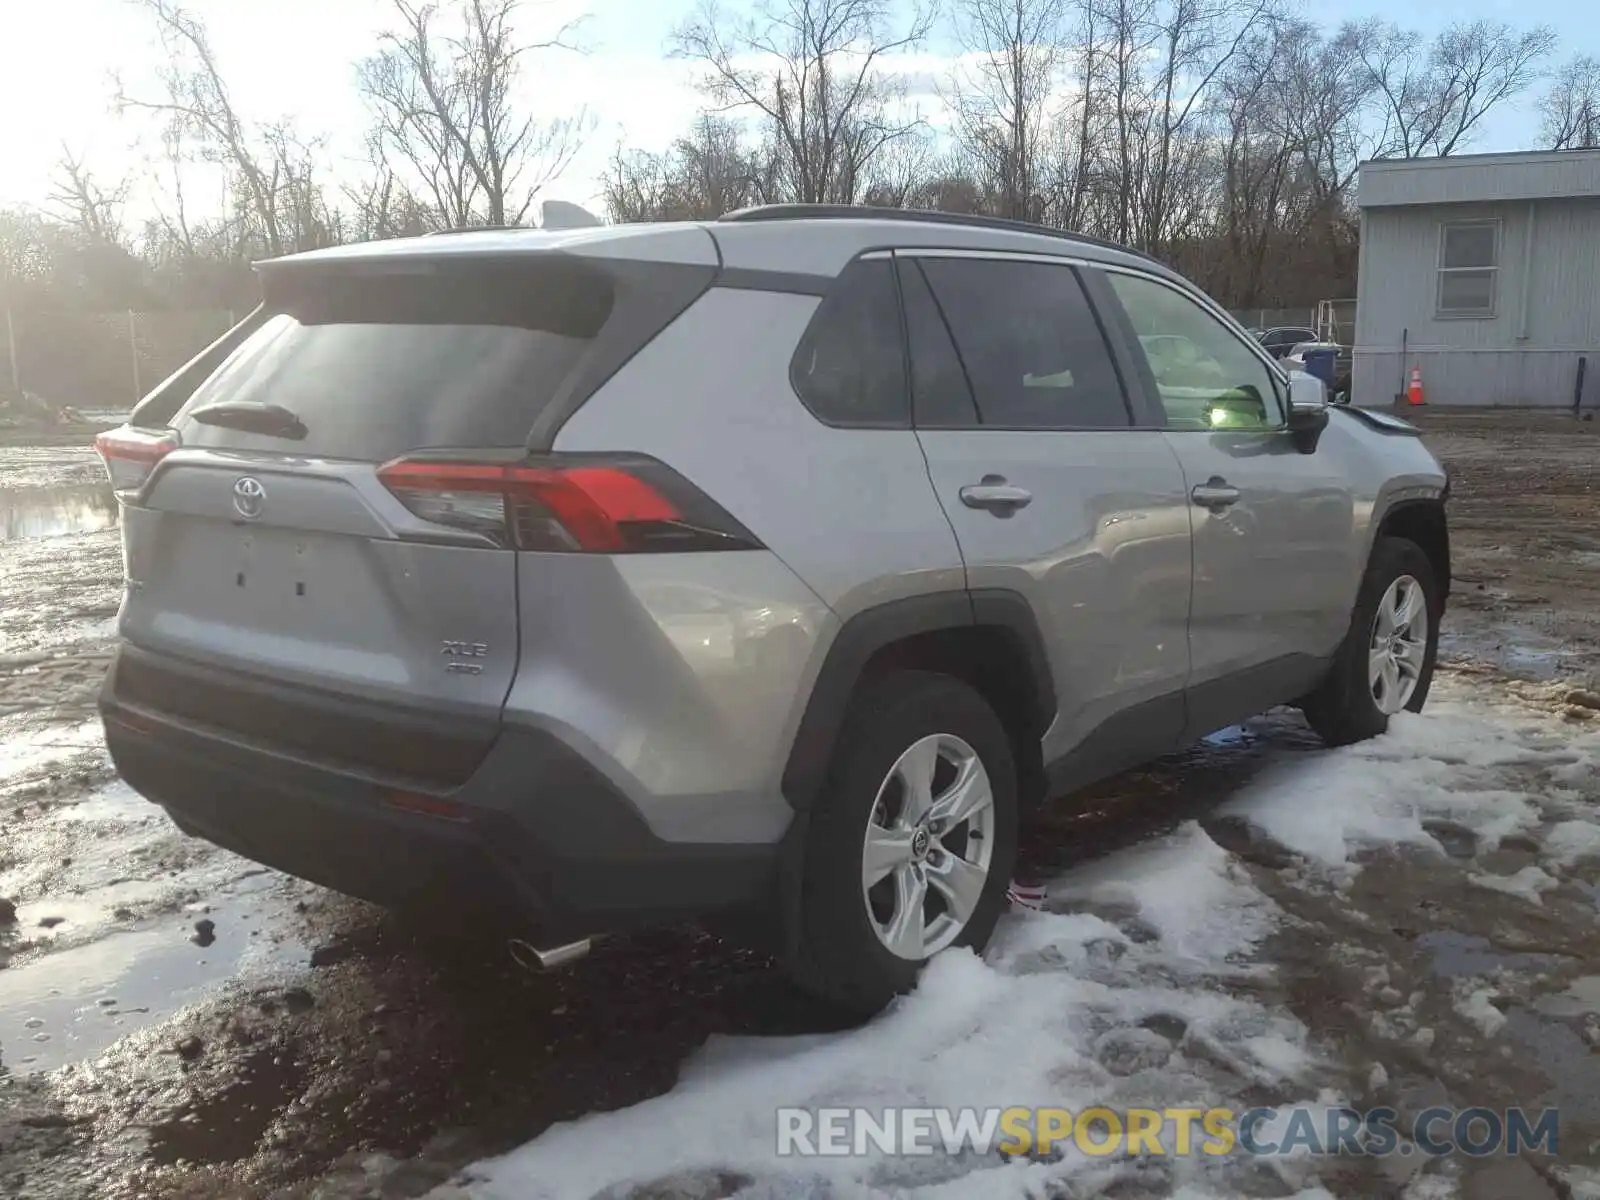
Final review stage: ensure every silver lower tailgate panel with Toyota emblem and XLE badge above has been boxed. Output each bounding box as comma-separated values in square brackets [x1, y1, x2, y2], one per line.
[118, 450, 518, 715]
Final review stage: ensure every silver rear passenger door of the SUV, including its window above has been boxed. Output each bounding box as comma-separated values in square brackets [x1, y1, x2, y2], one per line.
[896, 251, 1190, 789]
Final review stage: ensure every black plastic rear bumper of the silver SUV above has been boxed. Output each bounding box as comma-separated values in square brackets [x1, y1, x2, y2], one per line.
[101, 646, 779, 941]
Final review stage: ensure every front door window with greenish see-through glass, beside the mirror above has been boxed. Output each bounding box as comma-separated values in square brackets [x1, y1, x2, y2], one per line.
[1107, 272, 1283, 429]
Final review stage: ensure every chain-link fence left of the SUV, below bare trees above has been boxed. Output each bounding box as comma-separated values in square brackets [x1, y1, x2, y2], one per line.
[0, 307, 235, 424]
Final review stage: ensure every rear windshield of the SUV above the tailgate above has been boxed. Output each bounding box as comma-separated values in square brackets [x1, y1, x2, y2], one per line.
[173, 261, 614, 461]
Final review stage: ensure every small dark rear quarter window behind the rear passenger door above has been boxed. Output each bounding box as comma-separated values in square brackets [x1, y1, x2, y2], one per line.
[789, 259, 910, 427]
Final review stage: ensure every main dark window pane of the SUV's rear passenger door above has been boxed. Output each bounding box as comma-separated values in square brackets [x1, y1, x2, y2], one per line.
[922, 258, 1131, 429]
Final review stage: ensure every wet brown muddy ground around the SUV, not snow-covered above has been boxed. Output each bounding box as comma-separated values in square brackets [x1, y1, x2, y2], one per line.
[0, 413, 1600, 1200]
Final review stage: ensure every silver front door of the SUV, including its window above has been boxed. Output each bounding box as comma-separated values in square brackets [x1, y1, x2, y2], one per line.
[1098, 270, 1358, 736]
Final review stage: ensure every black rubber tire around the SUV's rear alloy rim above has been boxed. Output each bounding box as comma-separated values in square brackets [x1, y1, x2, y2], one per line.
[787, 670, 1018, 1016]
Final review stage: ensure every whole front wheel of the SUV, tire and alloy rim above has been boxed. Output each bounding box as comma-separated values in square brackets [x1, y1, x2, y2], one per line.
[1301, 538, 1445, 746]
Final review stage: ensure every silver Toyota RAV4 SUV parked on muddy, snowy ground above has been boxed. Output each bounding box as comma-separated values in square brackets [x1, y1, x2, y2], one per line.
[101, 206, 1450, 1011]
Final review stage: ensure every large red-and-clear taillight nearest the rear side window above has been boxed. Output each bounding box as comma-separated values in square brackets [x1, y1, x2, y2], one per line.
[378, 454, 760, 554]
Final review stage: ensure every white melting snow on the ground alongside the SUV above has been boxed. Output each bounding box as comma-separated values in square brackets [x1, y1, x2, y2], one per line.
[466, 680, 1600, 1200]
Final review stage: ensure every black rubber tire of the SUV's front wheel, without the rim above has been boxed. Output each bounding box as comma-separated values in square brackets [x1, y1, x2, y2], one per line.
[1301, 538, 1445, 746]
